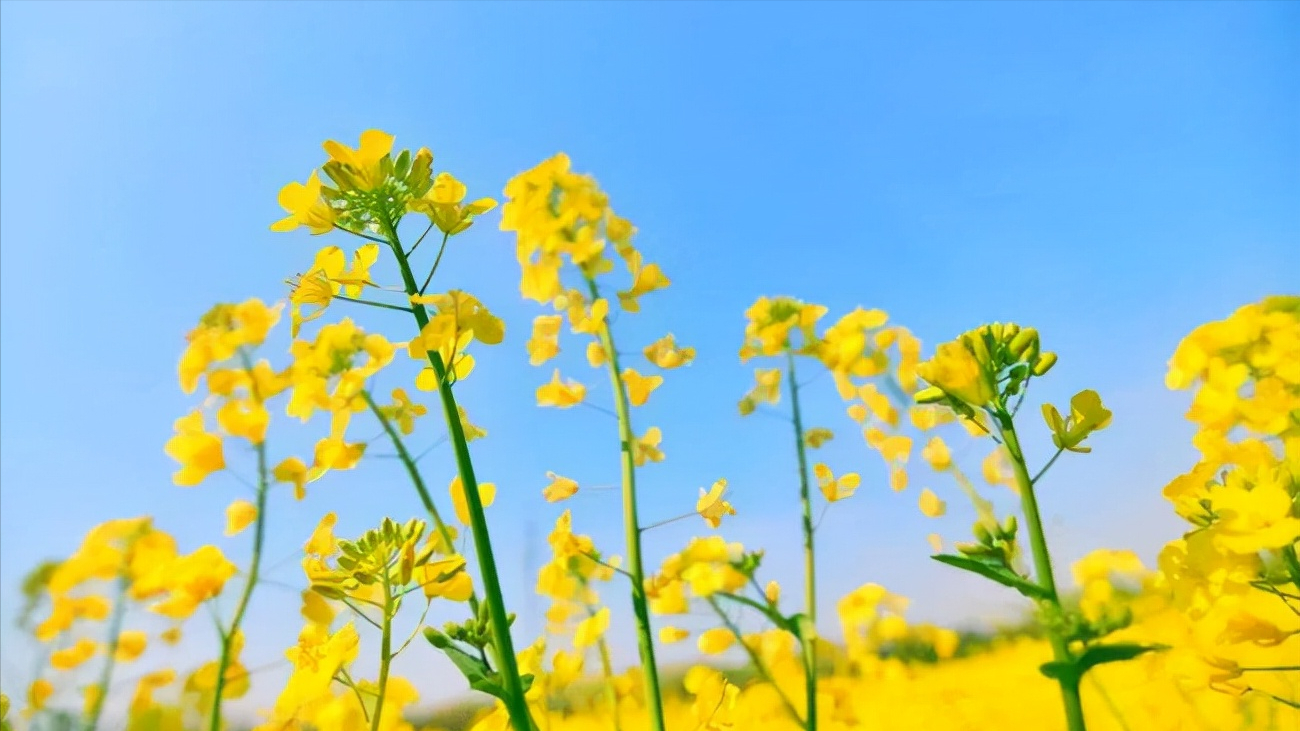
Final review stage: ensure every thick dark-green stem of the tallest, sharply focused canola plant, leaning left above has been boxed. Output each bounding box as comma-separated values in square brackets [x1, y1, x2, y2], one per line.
[384, 213, 533, 731]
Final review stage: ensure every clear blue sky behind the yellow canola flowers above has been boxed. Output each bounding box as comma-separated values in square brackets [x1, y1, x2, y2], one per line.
[0, 3, 1300, 705]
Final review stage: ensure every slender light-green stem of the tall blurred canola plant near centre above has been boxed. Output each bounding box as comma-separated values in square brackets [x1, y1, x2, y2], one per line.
[586, 277, 664, 731]
